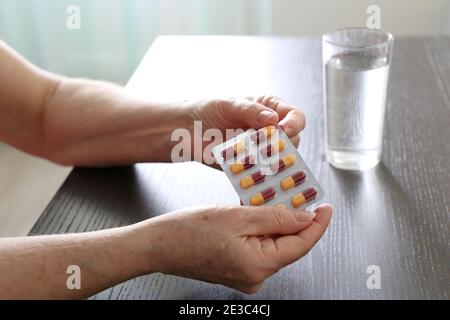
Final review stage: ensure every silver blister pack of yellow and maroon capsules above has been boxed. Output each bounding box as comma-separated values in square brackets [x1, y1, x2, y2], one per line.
[212, 126, 323, 209]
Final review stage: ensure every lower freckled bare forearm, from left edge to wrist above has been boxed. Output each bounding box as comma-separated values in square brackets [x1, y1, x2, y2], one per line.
[0, 221, 157, 299]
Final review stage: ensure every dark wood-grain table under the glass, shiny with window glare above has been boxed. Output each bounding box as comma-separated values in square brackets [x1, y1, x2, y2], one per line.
[30, 37, 450, 299]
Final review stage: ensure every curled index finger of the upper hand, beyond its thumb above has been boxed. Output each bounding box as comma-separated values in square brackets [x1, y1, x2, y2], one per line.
[256, 96, 305, 137]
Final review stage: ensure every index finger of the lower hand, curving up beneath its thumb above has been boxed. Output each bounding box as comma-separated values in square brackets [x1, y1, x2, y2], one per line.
[261, 206, 333, 268]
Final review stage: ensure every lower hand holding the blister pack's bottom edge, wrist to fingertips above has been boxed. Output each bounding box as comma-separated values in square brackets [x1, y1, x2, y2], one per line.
[139, 205, 333, 293]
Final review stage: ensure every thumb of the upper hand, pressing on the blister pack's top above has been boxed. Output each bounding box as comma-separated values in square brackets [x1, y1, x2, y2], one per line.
[222, 99, 279, 128]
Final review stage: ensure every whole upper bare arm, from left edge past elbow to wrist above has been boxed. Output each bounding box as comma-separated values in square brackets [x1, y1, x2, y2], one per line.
[0, 40, 192, 166]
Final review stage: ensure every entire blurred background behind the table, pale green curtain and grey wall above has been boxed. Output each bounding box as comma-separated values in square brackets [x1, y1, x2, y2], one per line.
[0, 0, 450, 84]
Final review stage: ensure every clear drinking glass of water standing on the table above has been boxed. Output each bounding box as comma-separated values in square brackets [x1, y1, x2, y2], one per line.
[322, 28, 394, 170]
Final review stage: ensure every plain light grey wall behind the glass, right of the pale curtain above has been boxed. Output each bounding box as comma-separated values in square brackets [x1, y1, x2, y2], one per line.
[271, 0, 450, 36]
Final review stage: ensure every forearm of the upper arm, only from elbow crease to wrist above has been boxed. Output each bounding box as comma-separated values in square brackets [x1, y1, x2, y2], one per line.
[43, 79, 192, 166]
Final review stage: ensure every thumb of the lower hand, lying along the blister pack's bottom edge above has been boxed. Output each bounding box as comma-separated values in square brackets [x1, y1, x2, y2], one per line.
[243, 207, 315, 236]
